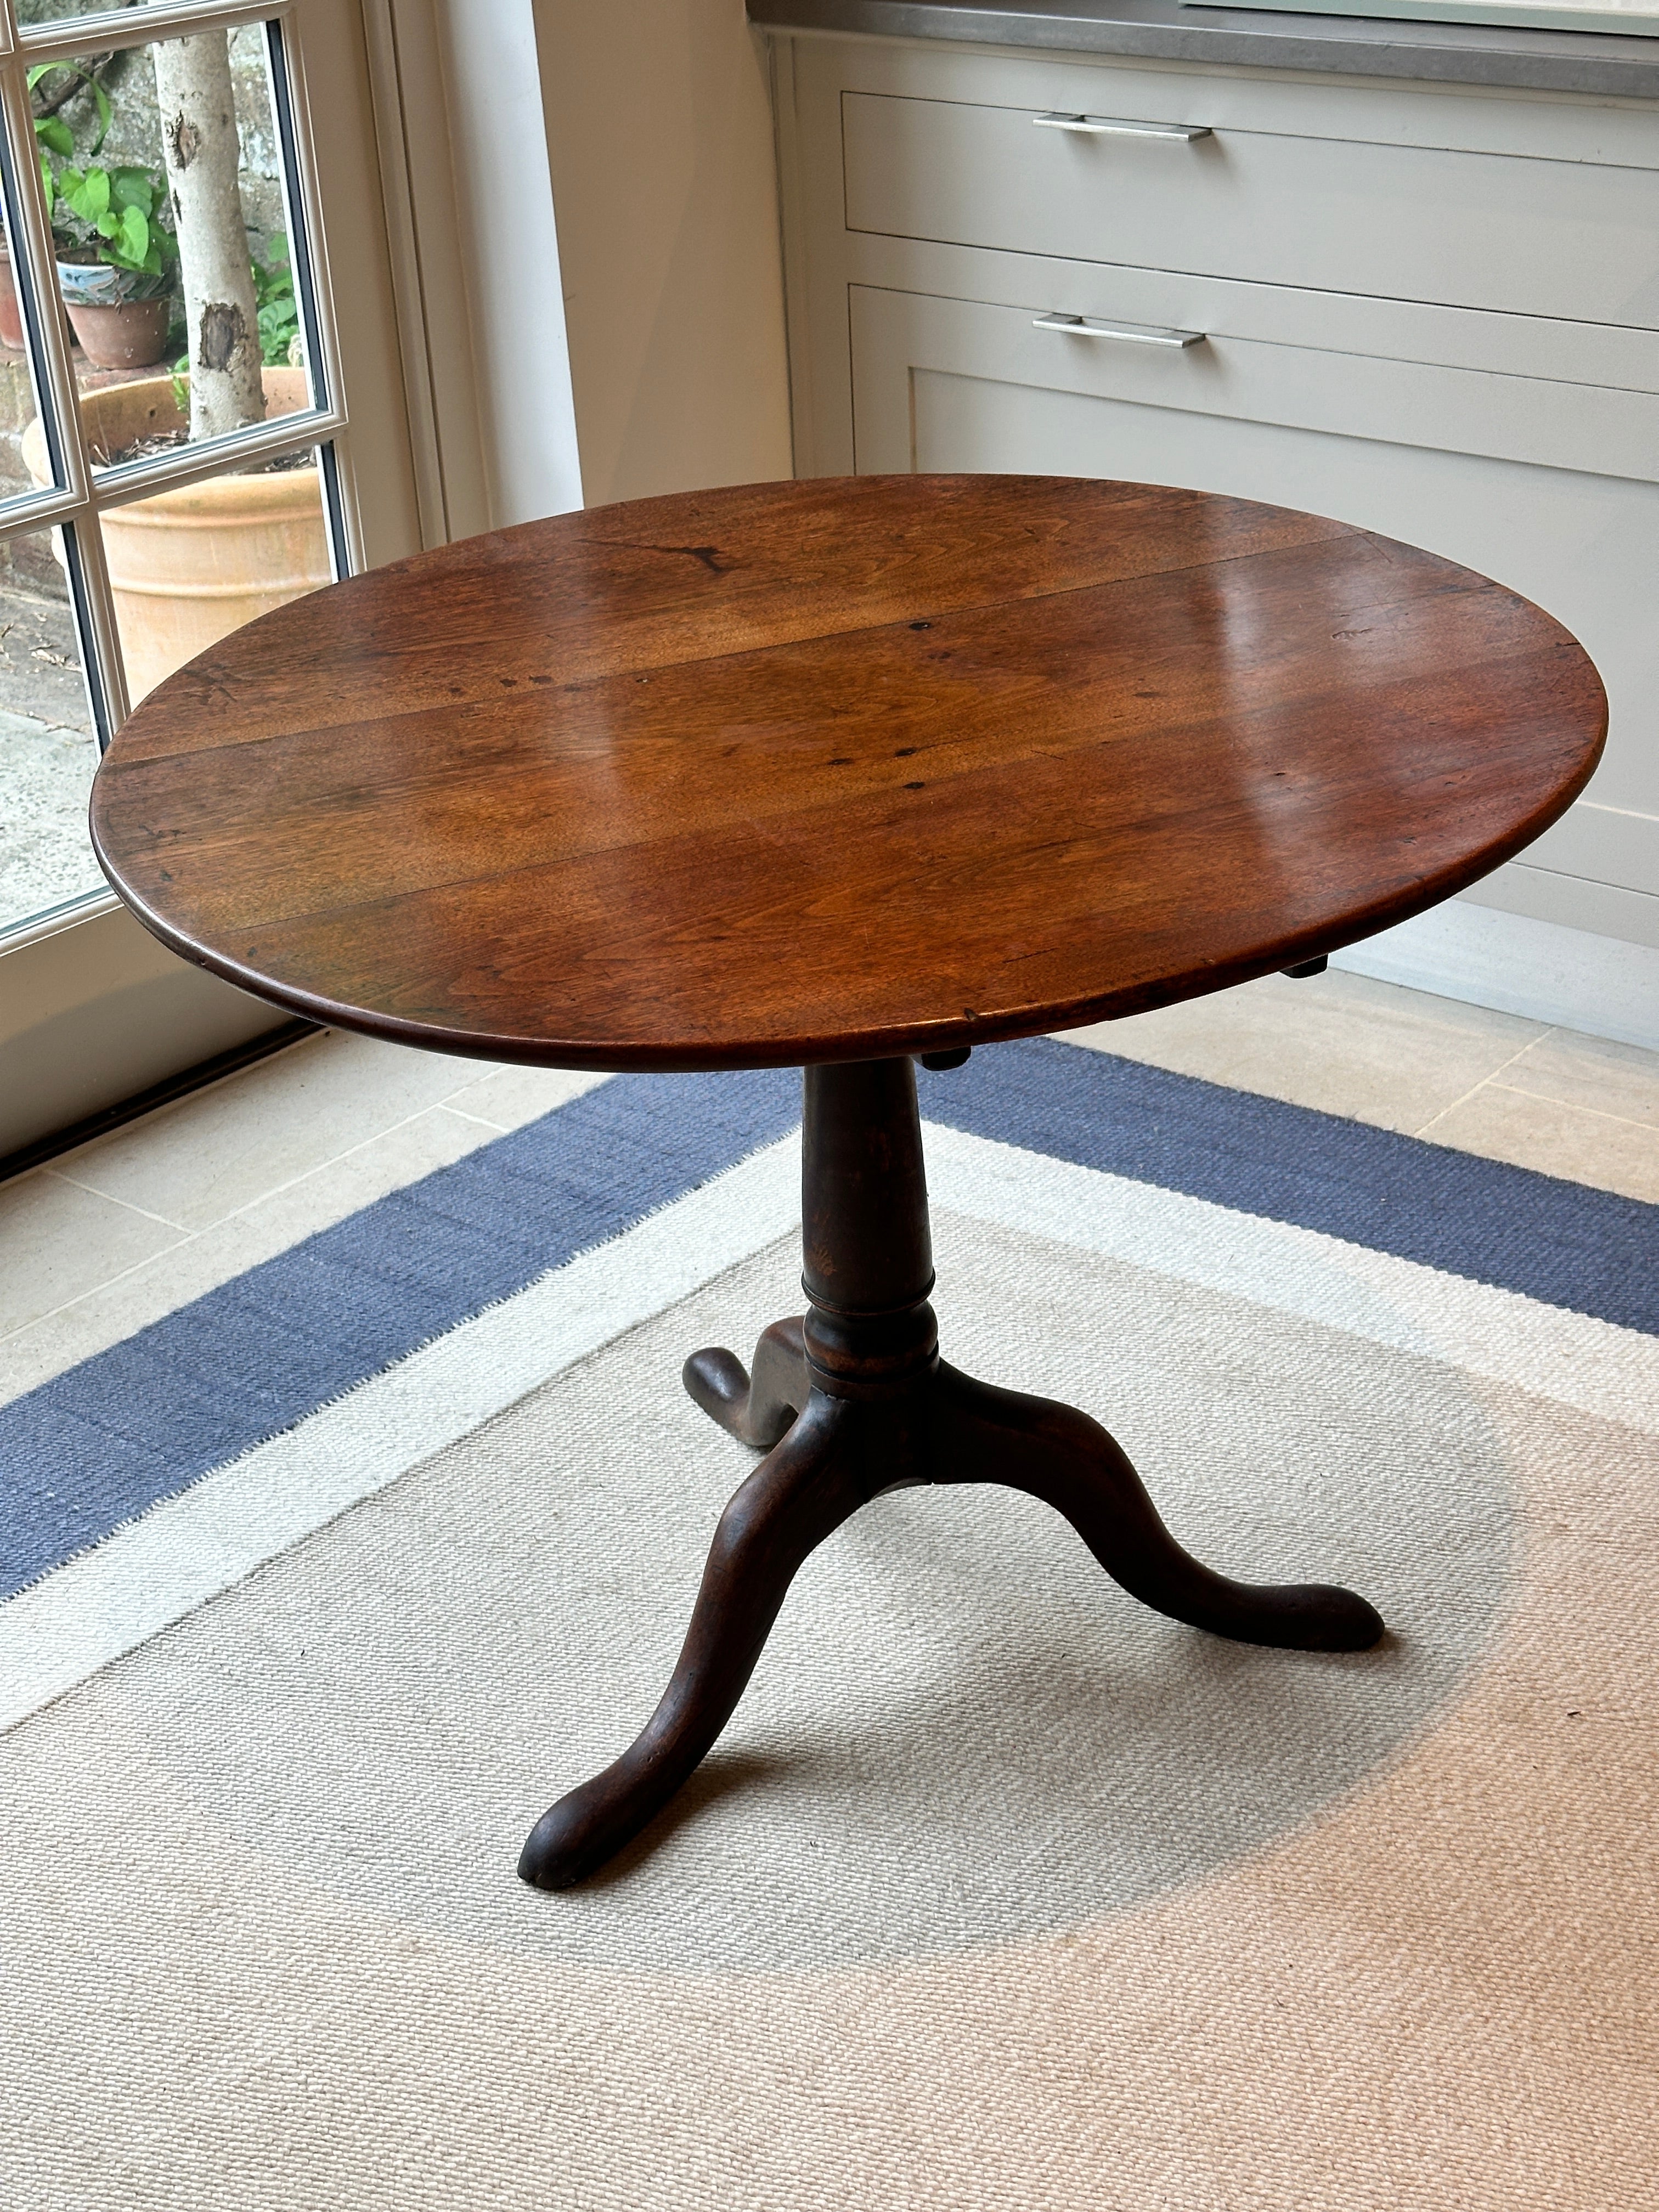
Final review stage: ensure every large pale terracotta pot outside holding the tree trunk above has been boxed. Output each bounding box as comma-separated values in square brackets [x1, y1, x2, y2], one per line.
[22, 369, 332, 701]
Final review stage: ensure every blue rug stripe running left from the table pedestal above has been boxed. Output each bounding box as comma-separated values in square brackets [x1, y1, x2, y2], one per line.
[0, 1068, 801, 1597]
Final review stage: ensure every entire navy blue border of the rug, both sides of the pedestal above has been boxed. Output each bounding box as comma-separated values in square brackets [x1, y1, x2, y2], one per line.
[0, 1040, 1659, 1597]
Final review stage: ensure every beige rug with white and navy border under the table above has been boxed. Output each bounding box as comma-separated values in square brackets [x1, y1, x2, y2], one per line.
[0, 1042, 1659, 2212]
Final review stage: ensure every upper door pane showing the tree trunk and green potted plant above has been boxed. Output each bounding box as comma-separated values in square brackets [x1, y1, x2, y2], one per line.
[31, 24, 312, 465]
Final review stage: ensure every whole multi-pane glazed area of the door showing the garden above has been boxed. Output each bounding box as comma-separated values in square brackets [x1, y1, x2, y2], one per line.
[0, 0, 363, 929]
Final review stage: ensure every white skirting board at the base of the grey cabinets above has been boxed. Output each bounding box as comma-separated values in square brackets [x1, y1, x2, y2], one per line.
[1331, 898, 1659, 1051]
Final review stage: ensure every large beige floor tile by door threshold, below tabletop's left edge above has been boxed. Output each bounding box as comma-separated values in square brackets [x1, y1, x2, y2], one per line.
[47, 1033, 487, 1230]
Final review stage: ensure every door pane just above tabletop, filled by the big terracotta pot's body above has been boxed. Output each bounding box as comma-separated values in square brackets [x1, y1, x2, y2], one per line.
[101, 449, 334, 706]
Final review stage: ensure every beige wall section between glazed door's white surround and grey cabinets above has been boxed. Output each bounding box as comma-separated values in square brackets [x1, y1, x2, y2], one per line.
[533, 0, 792, 506]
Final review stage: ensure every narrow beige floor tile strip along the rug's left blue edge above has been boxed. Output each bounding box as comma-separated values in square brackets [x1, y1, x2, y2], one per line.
[0, 1106, 513, 1400]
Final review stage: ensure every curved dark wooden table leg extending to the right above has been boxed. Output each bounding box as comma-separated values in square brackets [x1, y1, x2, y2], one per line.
[934, 1365, 1383, 1652]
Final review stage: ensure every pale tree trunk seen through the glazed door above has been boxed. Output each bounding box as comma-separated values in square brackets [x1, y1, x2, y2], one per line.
[150, 31, 266, 438]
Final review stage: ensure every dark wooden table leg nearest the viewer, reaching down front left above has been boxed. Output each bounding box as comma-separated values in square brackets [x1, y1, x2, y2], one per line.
[517, 1393, 867, 1889]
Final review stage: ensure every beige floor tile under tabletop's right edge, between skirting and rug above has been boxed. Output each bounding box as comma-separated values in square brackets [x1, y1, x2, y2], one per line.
[1066, 969, 1546, 1132]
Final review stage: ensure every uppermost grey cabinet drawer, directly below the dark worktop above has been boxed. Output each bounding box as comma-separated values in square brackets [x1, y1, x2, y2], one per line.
[843, 94, 1659, 330]
